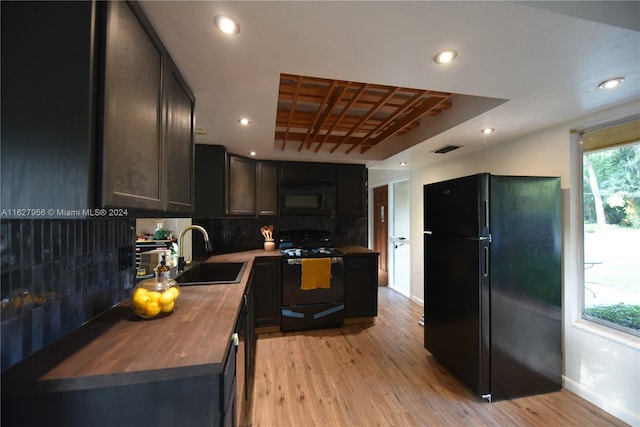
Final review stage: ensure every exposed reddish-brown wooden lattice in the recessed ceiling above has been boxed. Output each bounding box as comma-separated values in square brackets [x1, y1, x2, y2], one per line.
[275, 74, 454, 154]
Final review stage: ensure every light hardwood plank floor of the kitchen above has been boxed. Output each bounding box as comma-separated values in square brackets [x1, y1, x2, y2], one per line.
[238, 287, 626, 427]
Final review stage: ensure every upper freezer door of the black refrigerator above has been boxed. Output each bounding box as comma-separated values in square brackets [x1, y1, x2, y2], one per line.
[424, 173, 489, 237]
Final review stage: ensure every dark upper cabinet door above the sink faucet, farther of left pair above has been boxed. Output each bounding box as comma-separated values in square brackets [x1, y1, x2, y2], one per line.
[165, 62, 194, 213]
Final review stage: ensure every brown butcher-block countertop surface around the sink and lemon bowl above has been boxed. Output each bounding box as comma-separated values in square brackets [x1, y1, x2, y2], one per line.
[2, 250, 280, 394]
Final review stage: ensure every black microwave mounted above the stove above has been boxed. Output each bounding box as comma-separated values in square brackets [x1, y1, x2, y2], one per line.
[279, 183, 336, 215]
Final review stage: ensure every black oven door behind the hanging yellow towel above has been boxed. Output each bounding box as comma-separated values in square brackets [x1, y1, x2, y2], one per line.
[282, 257, 344, 306]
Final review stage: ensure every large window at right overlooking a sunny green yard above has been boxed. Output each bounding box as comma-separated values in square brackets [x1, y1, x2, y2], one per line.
[582, 120, 640, 335]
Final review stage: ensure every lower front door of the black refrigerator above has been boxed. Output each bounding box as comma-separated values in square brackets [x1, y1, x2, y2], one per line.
[424, 234, 489, 396]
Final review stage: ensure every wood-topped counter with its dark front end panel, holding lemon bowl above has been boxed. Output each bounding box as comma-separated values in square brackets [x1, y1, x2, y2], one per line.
[2, 250, 280, 427]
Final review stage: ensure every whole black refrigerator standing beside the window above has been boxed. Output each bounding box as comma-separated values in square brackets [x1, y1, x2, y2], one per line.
[424, 173, 562, 401]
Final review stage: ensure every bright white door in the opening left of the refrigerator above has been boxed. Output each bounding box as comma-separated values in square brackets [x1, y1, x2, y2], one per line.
[389, 179, 411, 297]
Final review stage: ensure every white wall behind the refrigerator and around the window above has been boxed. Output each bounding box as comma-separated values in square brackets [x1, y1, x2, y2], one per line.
[369, 103, 640, 426]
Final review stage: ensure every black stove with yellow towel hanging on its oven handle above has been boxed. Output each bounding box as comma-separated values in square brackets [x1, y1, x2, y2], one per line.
[279, 230, 344, 331]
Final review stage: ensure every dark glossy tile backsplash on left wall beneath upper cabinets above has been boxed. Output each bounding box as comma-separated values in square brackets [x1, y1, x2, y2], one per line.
[0, 218, 135, 371]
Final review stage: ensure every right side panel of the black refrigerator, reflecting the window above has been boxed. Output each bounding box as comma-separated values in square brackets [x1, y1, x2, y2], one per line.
[490, 176, 562, 400]
